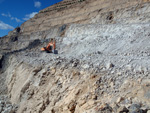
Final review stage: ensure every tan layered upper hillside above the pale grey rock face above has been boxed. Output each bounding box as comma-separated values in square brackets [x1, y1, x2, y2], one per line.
[21, 0, 150, 34]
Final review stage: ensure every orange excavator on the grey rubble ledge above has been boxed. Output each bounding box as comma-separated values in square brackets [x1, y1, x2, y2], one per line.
[41, 38, 56, 53]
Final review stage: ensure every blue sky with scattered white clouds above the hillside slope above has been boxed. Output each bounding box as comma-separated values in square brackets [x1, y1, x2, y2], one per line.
[0, 0, 62, 37]
